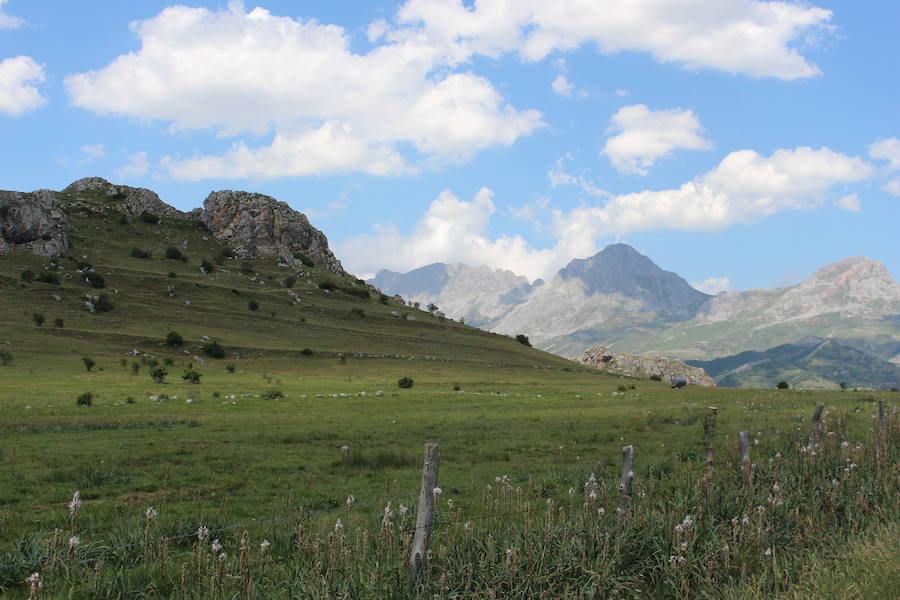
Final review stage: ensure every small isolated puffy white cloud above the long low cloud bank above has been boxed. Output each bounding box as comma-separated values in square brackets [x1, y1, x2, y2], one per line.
[602, 104, 712, 175]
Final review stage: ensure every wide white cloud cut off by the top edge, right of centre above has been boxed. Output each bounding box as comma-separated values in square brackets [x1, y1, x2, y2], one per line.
[398, 0, 832, 80]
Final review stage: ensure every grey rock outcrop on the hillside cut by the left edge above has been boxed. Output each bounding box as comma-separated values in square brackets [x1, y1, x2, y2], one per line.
[0, 190, 69, 257]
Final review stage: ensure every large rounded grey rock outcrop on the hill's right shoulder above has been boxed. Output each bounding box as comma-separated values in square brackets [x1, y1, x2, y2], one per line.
[200, 190, 343, 273]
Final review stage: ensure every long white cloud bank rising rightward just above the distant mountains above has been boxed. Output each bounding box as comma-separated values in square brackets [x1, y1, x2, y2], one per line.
[338, 147, 872, 289]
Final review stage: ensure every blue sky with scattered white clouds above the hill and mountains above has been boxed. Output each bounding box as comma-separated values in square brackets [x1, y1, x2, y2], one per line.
[0, 0, 900, 293]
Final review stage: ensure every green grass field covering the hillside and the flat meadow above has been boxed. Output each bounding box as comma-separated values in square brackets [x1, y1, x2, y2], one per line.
[0, 191, 898, 598]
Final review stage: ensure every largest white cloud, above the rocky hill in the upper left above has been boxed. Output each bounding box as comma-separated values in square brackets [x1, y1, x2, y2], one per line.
[66, 2, 543, 180]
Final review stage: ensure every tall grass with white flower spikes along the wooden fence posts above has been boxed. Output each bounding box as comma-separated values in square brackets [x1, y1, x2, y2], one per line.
[0, 408, 900, 599]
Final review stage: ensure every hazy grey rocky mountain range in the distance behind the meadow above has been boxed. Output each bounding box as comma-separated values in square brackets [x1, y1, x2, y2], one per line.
[369, 244, 900, 383]
